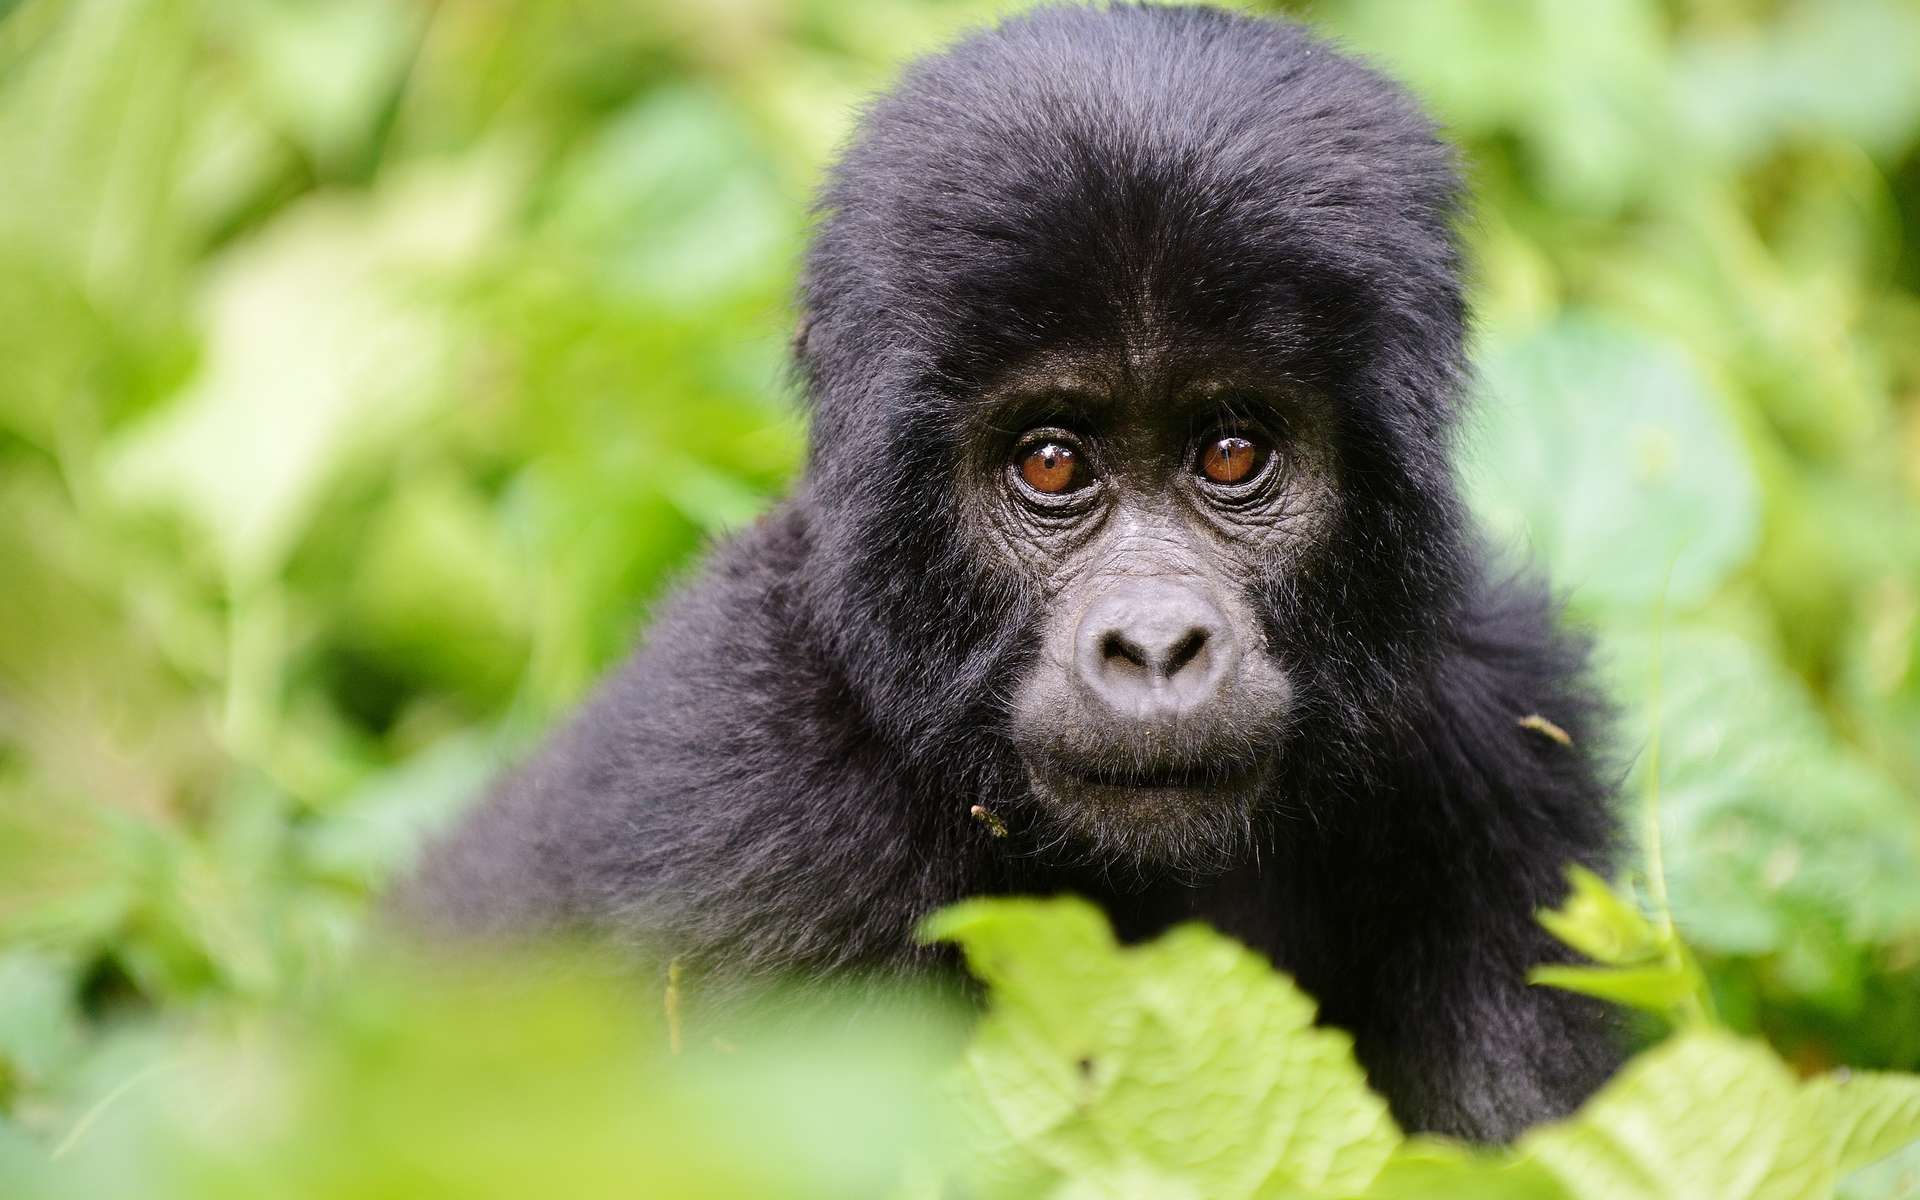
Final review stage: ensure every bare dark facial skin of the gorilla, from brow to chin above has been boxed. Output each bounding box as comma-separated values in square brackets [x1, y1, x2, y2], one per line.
[972, 341, 1336, 872]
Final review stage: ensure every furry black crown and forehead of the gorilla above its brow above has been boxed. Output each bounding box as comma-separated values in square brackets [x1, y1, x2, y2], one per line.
[804, 8, 1459, 409]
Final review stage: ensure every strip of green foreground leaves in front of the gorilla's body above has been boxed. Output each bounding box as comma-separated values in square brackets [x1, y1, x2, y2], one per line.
[0, 894, 1920, 1200]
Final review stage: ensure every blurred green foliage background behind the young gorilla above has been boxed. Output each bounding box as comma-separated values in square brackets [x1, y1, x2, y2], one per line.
[0, 0, 1920, 1194]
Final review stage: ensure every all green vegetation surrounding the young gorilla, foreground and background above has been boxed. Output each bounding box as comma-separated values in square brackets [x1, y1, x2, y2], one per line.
[0, 0, 1920, 1200]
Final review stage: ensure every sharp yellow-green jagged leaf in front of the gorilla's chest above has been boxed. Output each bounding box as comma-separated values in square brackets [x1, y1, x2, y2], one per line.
[925, 900, 1400, 1198]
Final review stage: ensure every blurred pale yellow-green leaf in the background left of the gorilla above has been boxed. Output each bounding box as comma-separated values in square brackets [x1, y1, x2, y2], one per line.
[109, 156, 511, 584]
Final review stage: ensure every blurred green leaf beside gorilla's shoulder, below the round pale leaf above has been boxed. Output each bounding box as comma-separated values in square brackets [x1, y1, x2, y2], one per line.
[1603, 628, 1920, 975]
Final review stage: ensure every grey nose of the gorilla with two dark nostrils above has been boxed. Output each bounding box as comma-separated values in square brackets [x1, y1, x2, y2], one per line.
[1073, 580, 1238, 718]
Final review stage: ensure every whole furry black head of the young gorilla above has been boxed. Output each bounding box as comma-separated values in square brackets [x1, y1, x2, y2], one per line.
[797, 10, 1471, 877]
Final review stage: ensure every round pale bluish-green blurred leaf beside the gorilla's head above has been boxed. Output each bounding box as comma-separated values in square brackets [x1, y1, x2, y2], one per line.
[1467, 317, 1759, 611]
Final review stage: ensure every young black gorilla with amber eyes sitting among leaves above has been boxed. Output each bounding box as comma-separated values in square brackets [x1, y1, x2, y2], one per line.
[407, 8, 1615, 1139]
